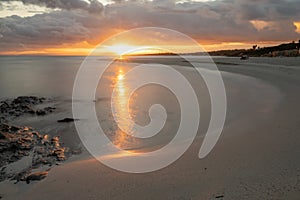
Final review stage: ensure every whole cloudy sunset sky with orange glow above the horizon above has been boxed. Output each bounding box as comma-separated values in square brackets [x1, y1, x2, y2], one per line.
[0, 0, 300, 55]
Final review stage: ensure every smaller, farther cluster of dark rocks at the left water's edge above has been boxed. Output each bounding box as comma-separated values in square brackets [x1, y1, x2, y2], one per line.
[0, 96, 55, 122]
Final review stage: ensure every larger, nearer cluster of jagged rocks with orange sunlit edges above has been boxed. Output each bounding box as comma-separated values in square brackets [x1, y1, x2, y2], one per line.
[0, 123, 71, 182]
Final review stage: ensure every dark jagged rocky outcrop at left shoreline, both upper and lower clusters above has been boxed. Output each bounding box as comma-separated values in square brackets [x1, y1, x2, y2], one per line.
[0, 96, 76, 183]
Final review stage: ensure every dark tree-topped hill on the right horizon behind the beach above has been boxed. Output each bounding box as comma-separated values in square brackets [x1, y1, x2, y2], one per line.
[209, 40, 300, 57]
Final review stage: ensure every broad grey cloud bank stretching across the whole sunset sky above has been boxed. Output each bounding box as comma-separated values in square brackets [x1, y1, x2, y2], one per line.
[0, 0, 300, 51]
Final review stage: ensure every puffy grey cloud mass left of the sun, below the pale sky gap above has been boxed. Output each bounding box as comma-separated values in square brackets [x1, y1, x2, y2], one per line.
[0, 11, 97, 50]
